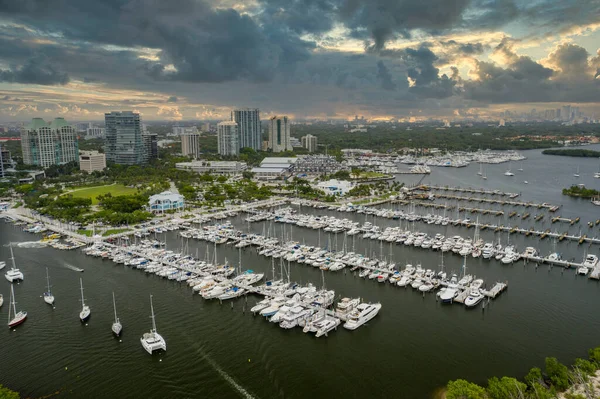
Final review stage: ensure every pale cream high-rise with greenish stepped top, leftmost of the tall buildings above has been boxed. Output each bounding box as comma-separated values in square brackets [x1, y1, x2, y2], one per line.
[21, 118, 79, 168]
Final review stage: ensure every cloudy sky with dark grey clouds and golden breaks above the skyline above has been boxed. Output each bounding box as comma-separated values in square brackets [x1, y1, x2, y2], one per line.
[0, 0, 600, 121]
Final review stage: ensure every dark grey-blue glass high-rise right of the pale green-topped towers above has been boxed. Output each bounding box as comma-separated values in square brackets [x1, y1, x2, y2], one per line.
[104, 111, 151, 165]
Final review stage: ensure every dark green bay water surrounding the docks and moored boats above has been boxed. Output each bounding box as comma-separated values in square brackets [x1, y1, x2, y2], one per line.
[0, 146, 600, 398]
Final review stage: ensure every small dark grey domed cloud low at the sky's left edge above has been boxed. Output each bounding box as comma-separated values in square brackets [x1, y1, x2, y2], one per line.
[0, 57, 69, 85]
